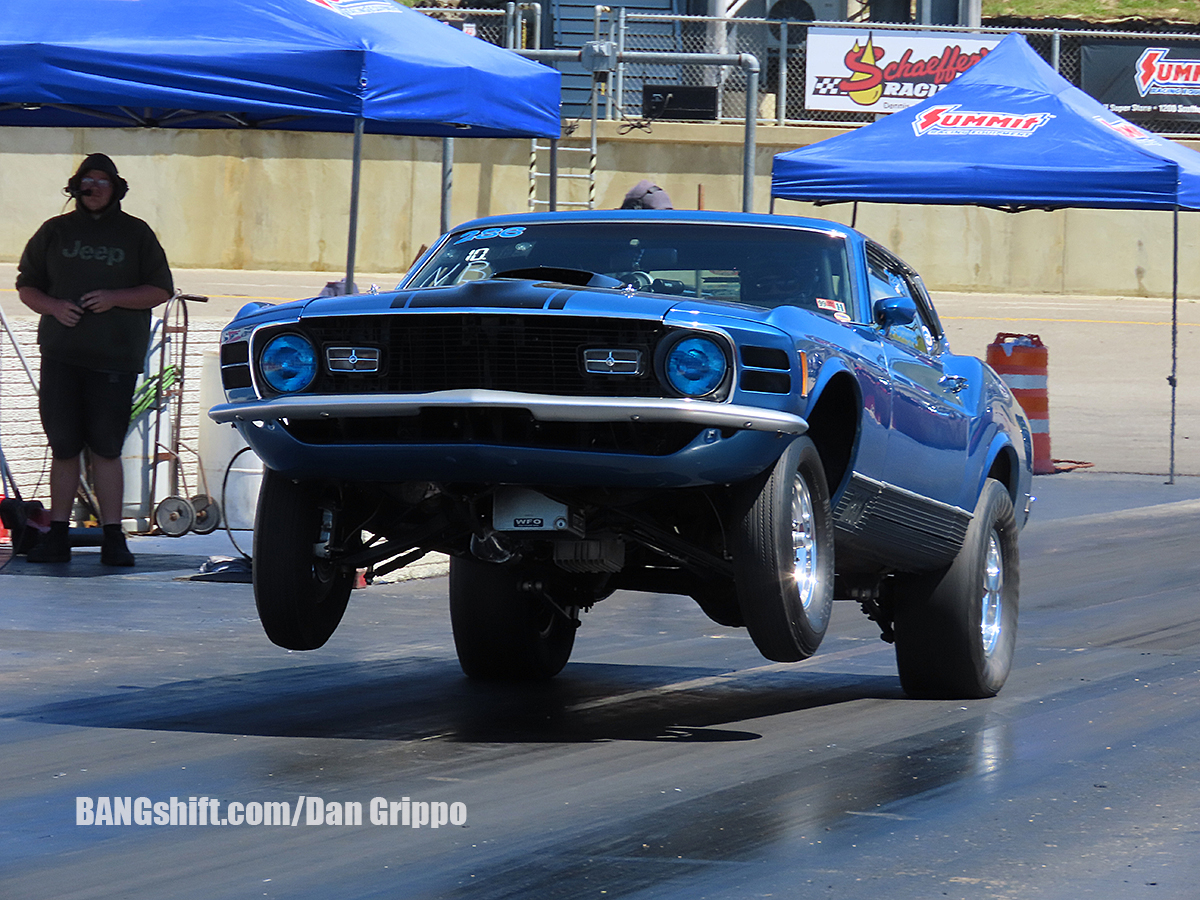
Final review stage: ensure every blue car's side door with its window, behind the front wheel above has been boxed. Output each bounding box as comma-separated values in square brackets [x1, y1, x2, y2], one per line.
[866, 245, 980, 505]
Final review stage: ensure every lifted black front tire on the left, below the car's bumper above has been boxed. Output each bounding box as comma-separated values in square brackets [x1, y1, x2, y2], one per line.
[253, 469, 355, 650]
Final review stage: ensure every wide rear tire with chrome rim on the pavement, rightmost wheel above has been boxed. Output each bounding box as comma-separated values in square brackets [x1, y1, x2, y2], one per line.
[893, 479, 1020, 700]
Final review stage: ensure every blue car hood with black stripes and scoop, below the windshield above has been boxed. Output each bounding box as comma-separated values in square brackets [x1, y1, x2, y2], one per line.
[290, 278, 787, 331]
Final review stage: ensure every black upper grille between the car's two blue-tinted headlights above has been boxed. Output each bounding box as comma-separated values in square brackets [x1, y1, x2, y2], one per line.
[290, 313, 665, 397]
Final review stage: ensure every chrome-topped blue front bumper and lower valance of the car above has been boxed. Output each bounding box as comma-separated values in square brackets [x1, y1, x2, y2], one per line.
[209, 390, 808, 487]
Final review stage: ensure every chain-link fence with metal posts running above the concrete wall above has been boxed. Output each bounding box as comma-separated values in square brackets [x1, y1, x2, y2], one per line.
[421, 4, 1200, 137]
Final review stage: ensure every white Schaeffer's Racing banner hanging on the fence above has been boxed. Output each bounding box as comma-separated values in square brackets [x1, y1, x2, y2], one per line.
[804, 28, 1002, 113]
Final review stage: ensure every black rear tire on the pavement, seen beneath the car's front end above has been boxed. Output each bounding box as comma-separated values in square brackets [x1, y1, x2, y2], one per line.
[450, 558, 576, 680]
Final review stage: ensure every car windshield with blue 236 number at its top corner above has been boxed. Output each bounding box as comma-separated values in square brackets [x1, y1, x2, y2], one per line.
[406, 222, 854, 320]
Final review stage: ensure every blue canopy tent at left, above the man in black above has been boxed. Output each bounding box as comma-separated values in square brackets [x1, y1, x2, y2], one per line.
[0, 0, 560, 284]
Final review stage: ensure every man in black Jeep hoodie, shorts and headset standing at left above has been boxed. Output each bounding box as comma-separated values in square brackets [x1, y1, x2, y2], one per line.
[17, 154, 174, 565]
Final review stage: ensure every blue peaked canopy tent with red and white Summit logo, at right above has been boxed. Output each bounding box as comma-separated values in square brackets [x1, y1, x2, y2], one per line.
[772, 32, 1200, 482]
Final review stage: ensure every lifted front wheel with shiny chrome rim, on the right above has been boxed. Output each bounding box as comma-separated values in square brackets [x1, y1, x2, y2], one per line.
[731, 437, 833, 662]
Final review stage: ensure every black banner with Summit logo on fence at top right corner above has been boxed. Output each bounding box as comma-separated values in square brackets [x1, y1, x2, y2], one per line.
[1080, 41, 1200, 120]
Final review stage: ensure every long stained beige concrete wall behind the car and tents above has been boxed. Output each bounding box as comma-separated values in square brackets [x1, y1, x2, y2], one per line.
[0, 121, 1200, 296]
